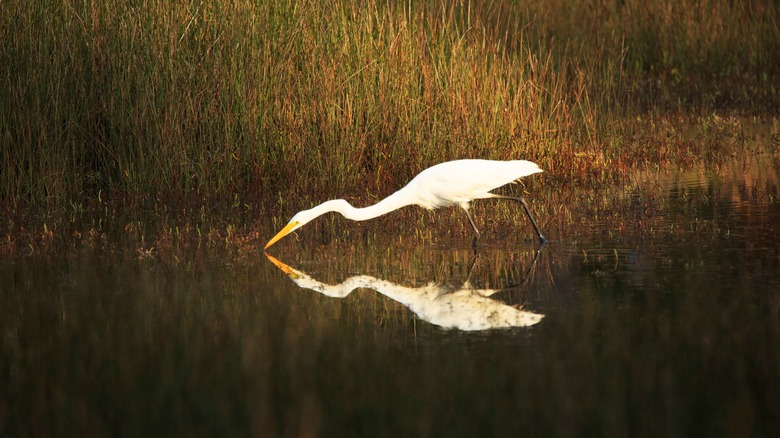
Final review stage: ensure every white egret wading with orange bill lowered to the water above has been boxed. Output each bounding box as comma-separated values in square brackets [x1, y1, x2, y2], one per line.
[265, 160, 547, 249]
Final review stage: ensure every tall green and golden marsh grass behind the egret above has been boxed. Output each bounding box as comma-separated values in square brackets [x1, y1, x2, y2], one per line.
[0, 0, 780, 211]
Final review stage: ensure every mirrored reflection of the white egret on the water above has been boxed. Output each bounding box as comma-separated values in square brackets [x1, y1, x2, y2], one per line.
[266, 253, 544, 331]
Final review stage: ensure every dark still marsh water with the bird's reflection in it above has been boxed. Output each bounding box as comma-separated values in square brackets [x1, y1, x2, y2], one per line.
[0, 142, 780, 436]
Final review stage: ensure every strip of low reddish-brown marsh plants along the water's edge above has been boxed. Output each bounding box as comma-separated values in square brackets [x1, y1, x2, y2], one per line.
[0, 116, 780, 265]
